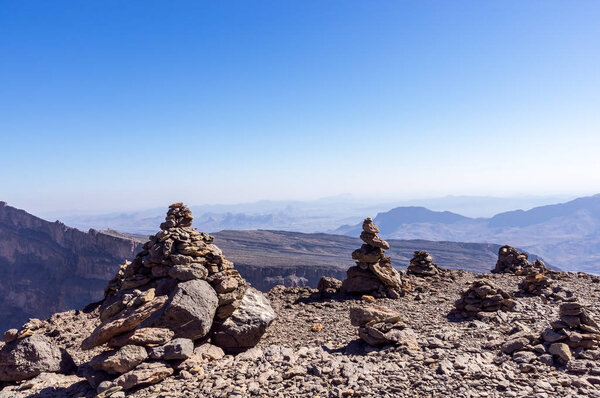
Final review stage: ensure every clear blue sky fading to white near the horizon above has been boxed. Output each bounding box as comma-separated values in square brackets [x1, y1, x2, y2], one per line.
[0, 0, 600, 212]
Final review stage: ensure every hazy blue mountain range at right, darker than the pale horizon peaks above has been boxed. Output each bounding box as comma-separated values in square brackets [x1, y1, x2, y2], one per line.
[334, 195, 600, 273]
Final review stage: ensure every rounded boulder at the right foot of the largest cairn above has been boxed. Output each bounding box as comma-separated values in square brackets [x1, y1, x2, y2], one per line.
[213, 287, 275, 352]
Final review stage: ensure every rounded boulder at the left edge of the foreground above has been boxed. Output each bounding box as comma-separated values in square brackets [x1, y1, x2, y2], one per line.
[0, 334, 67, 381]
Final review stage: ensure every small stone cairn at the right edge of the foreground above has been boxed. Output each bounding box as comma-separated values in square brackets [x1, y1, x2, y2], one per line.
[542, 301, 600, 365]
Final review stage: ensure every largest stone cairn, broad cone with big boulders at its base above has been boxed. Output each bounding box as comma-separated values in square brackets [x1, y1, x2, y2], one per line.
[78, 203, 275, 392]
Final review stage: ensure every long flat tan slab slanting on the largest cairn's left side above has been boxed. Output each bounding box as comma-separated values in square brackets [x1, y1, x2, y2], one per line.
[81, 296, 168, 350]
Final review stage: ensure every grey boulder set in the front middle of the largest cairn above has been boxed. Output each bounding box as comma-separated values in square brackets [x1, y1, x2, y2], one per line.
[142, 279, 219, 340]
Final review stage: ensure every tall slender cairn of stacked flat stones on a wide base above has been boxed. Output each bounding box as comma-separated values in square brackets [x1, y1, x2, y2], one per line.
[341, 217, 409, 298]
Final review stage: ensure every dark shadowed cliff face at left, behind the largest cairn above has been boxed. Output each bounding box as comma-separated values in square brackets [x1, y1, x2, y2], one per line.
[0, 202, 141, 329]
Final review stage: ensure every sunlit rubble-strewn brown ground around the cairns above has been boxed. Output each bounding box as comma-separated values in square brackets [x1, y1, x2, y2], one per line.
[0, 271, 600, 397]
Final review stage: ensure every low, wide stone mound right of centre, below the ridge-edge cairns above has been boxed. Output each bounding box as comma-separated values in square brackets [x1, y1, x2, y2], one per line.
[455, 280, 516, 317]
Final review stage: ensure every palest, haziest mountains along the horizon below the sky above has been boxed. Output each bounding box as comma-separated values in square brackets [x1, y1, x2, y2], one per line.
[45, 195, 572, 234]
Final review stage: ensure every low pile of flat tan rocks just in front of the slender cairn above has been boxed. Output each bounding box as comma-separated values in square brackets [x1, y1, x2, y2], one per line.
[350, 304, 419, 350]
